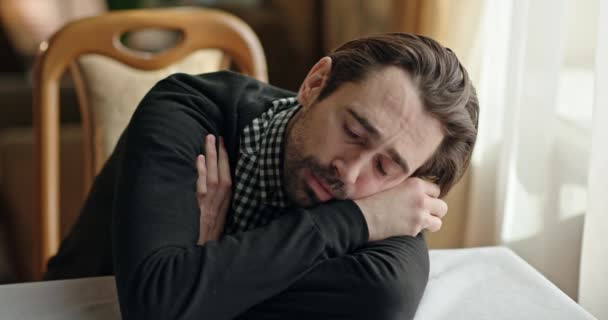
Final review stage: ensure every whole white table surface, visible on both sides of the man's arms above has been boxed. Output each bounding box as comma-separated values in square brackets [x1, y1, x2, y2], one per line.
[0, 247, 593, 320]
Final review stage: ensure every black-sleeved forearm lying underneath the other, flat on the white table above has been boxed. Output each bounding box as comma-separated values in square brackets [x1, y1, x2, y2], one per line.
[235, 235, 429, 319]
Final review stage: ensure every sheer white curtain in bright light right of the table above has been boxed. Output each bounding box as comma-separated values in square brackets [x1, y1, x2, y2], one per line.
[465, 0, 608, 299]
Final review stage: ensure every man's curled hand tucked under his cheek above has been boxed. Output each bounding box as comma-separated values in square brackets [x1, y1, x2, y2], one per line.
[355, 177, 448, 241]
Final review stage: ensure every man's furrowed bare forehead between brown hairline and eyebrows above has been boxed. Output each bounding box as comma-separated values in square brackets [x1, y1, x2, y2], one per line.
[337, 67, 443, 170]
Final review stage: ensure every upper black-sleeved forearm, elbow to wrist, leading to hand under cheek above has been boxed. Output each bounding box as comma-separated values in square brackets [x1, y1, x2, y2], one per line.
[115, 201, 367, 319]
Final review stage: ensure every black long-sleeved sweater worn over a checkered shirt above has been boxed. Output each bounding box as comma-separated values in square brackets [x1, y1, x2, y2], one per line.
[46, 71, 429, 319]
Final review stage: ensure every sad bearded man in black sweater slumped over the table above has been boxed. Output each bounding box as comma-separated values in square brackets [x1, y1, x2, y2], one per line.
[47, 34, 478, 319]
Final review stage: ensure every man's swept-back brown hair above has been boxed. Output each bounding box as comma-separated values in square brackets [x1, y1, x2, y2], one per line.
[318, 33, 479, 197]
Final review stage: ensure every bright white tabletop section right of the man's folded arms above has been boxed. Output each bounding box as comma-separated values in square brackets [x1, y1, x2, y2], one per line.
[415, 247, 594, 320]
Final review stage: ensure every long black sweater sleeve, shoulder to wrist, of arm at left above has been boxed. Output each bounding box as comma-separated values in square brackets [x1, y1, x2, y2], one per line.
[112, 75, 369, 319]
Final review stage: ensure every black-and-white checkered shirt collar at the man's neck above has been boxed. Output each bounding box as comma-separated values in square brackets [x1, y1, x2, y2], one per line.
[226, 97, 300, 234]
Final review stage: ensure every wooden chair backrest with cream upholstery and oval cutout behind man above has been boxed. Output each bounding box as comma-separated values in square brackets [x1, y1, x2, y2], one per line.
[33, 8, 267, 275]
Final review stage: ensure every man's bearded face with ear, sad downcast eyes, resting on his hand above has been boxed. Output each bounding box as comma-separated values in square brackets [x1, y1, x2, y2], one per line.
[284, 60, 443, 207]
